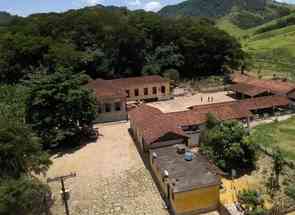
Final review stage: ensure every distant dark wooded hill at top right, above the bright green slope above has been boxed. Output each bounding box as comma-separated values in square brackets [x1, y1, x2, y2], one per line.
[159, 0, 292, 29]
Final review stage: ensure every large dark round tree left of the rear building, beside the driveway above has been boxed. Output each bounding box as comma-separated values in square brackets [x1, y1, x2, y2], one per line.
[26, 68, 96, 148]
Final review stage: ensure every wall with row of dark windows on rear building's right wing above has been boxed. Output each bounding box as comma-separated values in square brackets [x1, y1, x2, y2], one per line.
[125, 81, 171, 101]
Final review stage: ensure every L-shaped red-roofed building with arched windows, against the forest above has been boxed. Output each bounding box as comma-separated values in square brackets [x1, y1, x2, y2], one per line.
[87, 75, 170, 122]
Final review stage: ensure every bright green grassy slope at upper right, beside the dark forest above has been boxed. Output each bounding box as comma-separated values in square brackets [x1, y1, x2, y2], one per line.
[217, 9, 295, 80]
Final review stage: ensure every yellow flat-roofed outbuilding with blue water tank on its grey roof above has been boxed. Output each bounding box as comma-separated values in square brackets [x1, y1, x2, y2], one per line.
[150, 145, 222, 215]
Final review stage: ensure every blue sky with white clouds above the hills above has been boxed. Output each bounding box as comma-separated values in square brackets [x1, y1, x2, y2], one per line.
[0, 0, 295, 16]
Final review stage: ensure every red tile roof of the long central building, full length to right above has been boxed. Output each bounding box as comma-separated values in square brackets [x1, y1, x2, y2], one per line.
[129, 93, 289, 145]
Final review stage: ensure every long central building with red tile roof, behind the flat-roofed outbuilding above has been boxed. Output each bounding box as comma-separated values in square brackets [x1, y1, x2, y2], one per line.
[129, 96, 290, 151]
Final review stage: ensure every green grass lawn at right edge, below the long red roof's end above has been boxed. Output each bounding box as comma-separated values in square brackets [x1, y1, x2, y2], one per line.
[253, 117, 295, 161]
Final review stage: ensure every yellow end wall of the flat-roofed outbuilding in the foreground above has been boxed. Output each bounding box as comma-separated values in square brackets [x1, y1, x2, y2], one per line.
[170, 185, 220, 215]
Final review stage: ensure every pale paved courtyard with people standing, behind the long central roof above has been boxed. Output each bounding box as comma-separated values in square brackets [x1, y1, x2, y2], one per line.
[149, 91, 234, 113]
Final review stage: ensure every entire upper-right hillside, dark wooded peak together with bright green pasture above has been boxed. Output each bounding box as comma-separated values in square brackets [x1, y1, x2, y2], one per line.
[159, 0, 295, 80]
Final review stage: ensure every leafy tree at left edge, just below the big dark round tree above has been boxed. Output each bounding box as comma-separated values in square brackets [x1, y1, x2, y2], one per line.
[0, 118, 51, 178]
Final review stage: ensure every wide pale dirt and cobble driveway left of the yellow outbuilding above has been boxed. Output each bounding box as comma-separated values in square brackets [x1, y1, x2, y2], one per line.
[43, 123, 168, 215]
